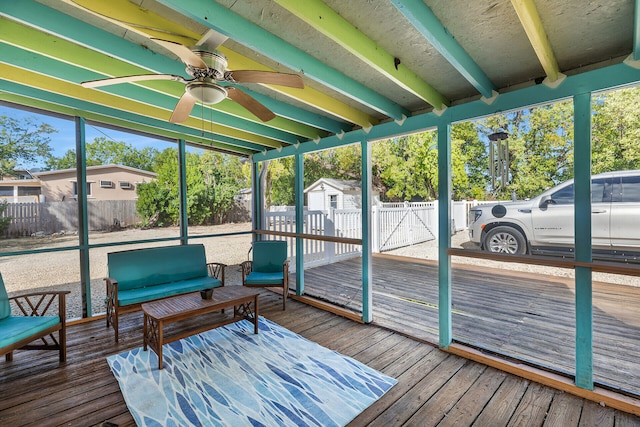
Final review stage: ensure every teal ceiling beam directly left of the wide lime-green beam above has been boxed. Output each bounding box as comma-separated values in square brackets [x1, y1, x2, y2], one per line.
[158, 0, 409, 120]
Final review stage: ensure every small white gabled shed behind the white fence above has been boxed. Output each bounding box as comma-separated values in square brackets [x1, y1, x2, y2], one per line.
[304, 178, 379, 211]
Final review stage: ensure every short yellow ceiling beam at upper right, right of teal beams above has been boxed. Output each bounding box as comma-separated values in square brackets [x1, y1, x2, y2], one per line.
[511, 0, 562, 82]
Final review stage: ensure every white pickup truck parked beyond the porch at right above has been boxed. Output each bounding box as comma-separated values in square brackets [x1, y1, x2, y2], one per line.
[469, 170, 640, 261]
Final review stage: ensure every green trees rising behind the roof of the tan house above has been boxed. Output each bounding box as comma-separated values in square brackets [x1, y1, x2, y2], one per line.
[47, 137, 159, 171]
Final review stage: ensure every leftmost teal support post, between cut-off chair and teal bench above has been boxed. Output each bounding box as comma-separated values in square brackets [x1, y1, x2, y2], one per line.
[75, 117, 93, 318]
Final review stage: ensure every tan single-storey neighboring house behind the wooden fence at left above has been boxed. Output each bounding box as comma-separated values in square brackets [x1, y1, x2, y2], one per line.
[33, 165, 156, 202]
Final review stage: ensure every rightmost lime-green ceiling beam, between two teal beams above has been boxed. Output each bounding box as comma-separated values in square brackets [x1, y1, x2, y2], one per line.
[275, 0, 449, 110]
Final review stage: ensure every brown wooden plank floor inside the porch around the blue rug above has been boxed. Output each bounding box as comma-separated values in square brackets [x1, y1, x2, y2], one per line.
[0, 290, 640, 427]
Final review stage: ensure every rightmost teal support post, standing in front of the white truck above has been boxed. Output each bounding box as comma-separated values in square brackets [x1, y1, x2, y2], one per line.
[573, 93, 593, 390]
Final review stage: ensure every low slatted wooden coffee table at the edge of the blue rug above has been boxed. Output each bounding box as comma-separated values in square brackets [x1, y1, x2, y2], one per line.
[142, 286, 259, 369]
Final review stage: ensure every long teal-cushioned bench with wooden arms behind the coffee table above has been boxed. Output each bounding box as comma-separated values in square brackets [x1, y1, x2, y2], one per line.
[105, 245, 226, 342]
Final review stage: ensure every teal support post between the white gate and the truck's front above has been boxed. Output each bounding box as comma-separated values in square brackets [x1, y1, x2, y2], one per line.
[438, 119, 453, 348]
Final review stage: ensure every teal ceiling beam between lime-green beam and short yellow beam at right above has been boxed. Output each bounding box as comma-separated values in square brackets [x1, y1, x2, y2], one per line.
[391, 0, 496, 98]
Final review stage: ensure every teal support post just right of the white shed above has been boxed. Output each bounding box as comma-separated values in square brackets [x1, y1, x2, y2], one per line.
[360, 139, 373, 323]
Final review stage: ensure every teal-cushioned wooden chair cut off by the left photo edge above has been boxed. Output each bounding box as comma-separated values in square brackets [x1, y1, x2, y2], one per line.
[0, 274, 69, 362]
